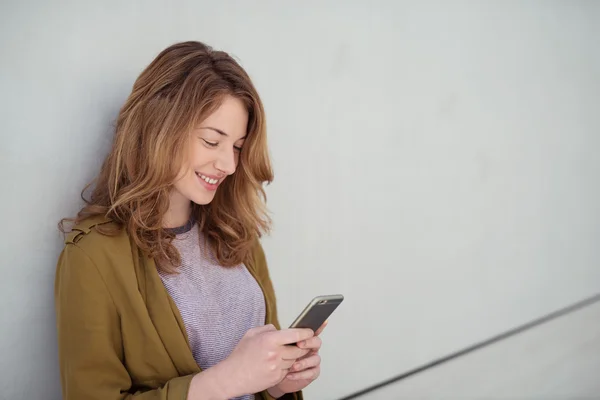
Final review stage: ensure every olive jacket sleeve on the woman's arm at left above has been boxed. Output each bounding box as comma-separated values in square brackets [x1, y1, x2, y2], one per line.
[54, 244, 193, 400]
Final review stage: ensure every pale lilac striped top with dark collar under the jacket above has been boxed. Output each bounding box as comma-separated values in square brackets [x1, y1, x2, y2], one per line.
[159, 222, 265, 400]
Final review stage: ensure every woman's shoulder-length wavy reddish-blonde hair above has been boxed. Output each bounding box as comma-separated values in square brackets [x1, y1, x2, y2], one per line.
[59, 41, 273, 272]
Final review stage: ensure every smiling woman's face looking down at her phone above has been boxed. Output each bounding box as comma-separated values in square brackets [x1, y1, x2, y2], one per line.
[171, 96, 248, 207]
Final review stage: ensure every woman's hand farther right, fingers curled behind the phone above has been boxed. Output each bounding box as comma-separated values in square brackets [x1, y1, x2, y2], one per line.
[268, 321, 327, 398]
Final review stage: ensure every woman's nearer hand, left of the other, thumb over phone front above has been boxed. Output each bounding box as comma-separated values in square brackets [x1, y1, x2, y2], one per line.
[214, 325, 314, 399]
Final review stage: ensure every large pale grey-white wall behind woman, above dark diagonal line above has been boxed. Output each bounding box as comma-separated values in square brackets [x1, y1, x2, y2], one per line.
[0, 0, 600, 399]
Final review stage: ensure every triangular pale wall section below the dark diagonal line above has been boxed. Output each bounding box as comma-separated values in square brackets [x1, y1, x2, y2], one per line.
[361, 302, 600, 400]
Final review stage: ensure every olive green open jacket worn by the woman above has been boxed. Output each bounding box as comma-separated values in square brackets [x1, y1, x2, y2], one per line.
[55, 218, 302, 400]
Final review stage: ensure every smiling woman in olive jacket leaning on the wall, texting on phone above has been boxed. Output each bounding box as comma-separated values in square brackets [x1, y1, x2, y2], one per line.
[55, 42, 322, 400]
